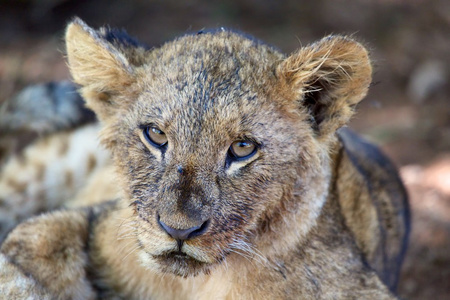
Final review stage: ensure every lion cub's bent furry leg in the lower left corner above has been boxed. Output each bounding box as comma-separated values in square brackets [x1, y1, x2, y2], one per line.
[0, 210, 95, 299]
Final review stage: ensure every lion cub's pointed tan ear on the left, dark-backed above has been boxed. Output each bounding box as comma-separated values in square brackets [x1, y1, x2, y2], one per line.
[66, 18, 146, 120]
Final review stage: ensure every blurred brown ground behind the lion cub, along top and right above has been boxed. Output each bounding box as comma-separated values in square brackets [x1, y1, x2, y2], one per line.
[0, 0, 450, 300]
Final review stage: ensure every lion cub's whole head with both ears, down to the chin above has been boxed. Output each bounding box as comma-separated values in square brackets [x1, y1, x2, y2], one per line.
[66, 20, 370, 276]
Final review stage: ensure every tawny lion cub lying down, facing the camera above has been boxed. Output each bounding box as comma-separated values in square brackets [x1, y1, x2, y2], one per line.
[0, 19, 408, 299]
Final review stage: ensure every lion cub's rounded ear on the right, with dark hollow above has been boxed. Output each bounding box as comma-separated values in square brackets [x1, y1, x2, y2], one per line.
[276, 36, 372, 139]
